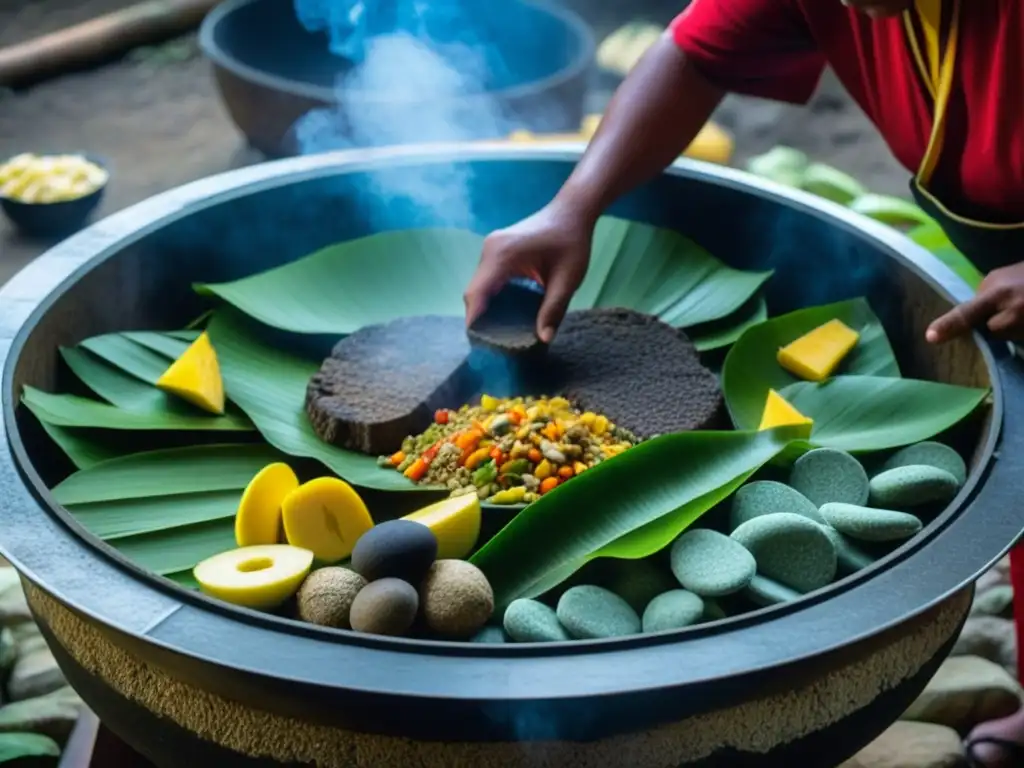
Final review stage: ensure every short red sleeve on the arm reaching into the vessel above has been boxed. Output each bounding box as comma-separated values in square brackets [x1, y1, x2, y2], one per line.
[670, 0, 825, 103]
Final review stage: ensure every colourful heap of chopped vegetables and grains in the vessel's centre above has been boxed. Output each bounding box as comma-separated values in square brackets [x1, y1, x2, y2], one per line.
[379, 394, 638, 504]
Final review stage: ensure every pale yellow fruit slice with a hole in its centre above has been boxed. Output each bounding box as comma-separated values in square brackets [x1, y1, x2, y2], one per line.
[193, 544, 313, 609]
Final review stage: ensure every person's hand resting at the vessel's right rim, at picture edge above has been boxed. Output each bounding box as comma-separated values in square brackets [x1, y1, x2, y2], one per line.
[925, 262, 1024, 344]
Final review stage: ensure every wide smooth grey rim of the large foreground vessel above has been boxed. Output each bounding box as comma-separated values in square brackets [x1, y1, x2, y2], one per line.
[0, 142, 1024, 701]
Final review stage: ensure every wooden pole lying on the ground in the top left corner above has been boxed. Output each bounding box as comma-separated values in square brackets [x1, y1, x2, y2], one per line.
[0, 0, 217, 88]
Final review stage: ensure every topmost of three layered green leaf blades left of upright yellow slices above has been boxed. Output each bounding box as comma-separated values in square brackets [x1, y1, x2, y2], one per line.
[53, 443, 287, 506]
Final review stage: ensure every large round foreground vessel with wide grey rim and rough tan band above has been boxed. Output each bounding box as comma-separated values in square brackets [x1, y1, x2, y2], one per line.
[0, 144, 1024, 768]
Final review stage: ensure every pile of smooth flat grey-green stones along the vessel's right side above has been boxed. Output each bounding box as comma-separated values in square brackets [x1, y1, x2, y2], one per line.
[493, 442, 967, 643]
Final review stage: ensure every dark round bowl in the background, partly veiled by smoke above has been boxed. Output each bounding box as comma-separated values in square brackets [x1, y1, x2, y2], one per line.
[200, 0, 594, 157]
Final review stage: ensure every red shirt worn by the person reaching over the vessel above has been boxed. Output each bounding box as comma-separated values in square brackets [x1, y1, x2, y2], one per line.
[672, 0, 1024, 222]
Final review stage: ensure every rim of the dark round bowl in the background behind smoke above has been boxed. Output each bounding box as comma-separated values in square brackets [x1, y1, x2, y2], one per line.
[199, 0, 597, 104]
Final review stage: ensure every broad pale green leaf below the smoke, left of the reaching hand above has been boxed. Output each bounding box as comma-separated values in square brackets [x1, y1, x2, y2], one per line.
[196, 229, 483, 335]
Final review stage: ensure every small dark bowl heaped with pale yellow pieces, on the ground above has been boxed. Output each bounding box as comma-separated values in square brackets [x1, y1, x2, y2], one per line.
[0, 153, 110, 237]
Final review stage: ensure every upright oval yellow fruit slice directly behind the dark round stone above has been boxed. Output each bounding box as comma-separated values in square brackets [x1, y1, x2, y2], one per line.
[281, 477, 374, 563]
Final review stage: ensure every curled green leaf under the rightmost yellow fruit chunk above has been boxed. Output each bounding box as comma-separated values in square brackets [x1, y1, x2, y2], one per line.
[722, 299, 899, 429]
